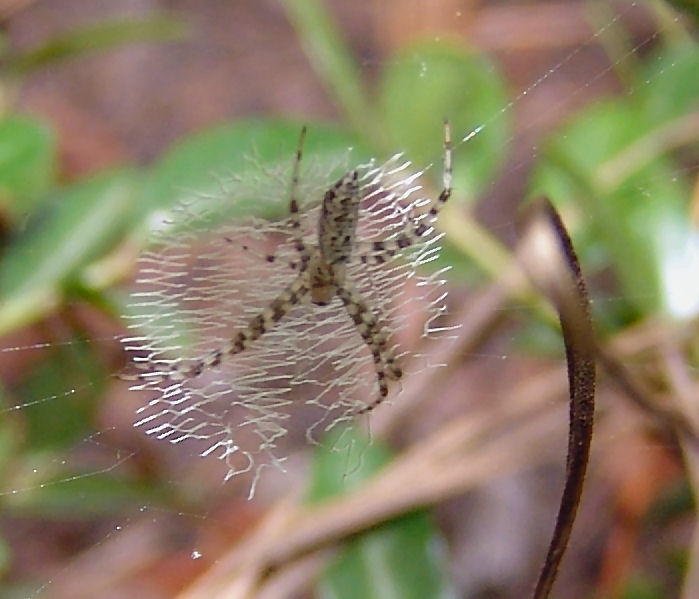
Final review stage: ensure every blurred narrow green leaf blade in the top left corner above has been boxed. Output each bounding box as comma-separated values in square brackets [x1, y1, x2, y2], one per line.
[5, 14, 187, 76]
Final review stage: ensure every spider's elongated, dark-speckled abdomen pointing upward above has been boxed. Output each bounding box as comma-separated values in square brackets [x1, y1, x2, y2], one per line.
[318, 170, 361, 264]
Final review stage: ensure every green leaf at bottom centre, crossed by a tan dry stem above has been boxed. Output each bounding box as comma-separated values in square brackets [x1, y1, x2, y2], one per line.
[309, 429, 453, 599]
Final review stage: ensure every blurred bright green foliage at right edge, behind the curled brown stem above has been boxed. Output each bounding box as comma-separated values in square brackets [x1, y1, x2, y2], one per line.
[532, 40, 699, 326]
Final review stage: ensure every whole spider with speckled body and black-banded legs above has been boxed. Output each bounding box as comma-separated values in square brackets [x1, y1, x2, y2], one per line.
[150, 121, 452, 414]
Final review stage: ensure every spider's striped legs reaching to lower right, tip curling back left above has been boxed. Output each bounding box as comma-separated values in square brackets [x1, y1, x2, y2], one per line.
[337, 287, 403, 414]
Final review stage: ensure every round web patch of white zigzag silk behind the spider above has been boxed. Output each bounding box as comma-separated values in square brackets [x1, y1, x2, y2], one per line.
[124, 146, 446, 488]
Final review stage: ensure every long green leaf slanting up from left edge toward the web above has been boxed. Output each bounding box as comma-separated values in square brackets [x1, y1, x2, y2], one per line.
[0, 171, 139, 334]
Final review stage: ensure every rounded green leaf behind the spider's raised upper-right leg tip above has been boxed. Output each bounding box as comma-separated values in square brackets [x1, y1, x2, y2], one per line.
[379, 42, 509, 196]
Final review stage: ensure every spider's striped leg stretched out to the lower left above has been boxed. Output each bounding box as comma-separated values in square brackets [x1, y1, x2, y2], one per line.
[163, 275, 309, 381]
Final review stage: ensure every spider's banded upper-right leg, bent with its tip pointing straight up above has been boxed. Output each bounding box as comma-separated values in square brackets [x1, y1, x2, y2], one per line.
[356, 121, 453, 264]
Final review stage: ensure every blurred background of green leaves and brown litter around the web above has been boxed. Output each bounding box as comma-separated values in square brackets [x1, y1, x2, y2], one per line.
[0, 0, 699, 599]
